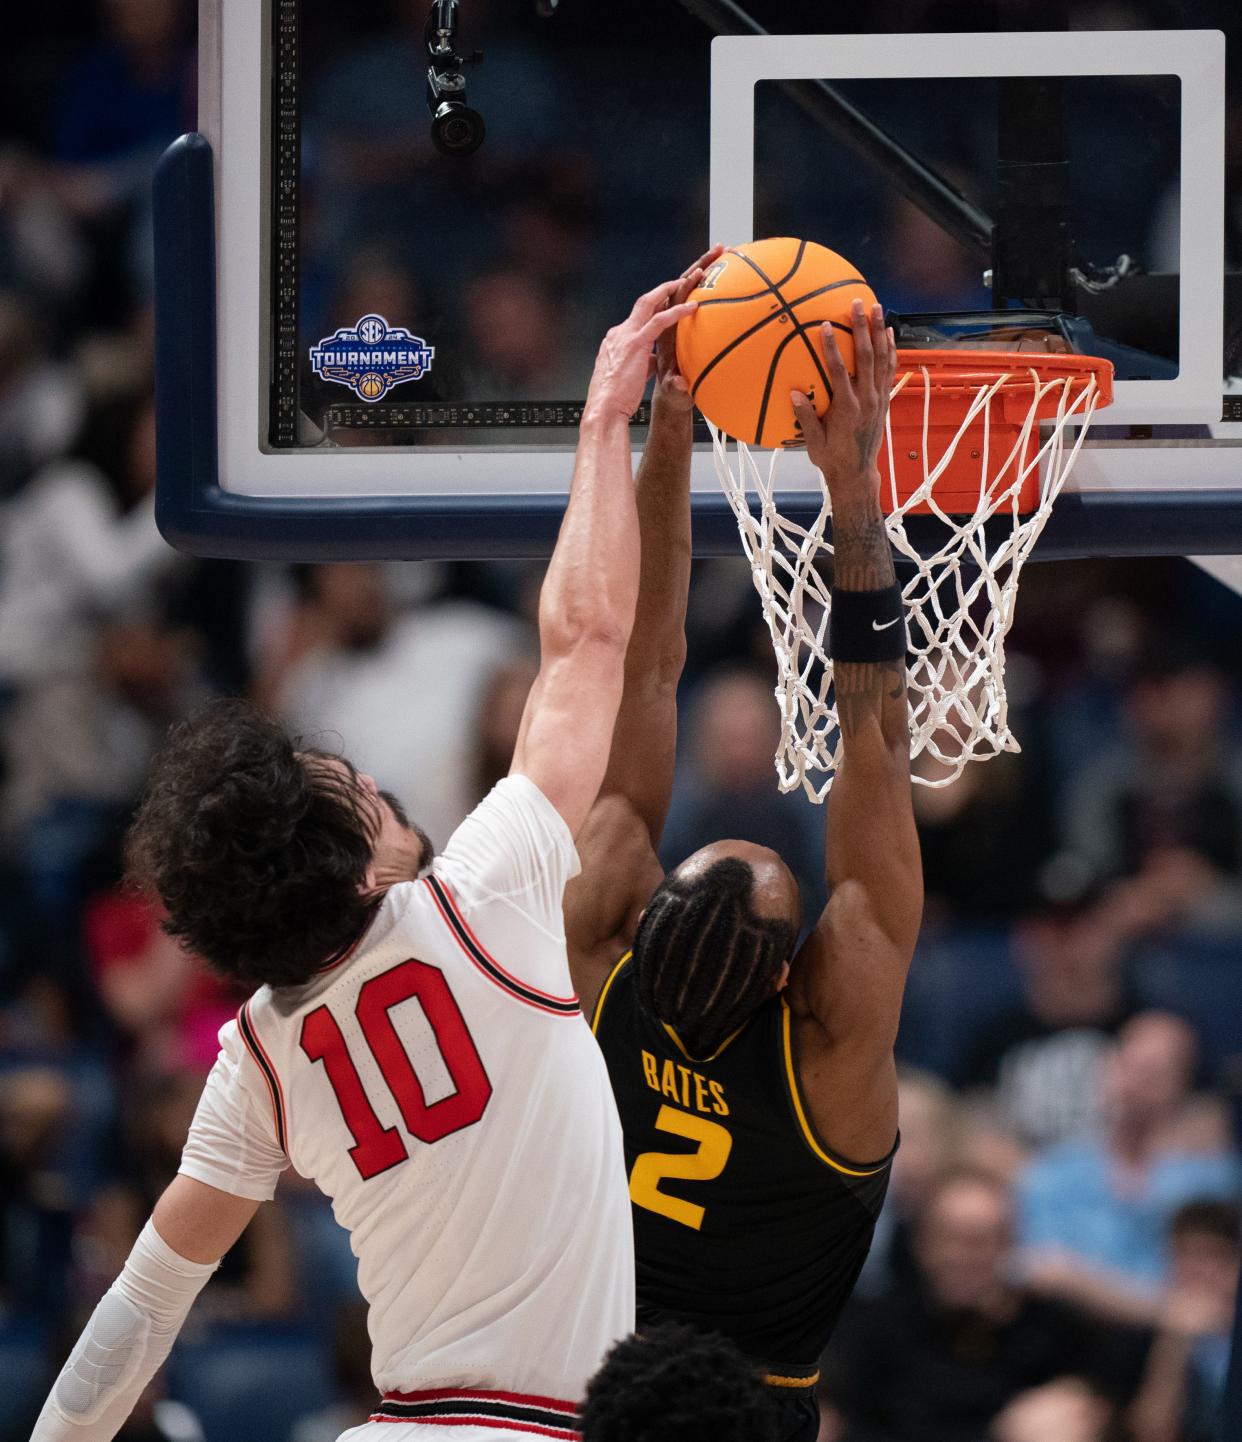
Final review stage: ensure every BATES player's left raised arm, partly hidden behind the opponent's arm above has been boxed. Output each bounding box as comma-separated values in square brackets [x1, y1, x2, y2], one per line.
[565, 245, 721, 1014]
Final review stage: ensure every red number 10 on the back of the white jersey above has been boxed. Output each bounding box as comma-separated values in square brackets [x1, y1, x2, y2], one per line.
[301, 960, 492, 1181]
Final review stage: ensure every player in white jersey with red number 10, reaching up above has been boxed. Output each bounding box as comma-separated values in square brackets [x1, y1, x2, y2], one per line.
[33, 271, 701, 1442]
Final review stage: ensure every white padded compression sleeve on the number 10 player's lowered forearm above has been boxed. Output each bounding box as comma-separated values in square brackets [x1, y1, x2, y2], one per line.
[30, 1221, 219, 1442]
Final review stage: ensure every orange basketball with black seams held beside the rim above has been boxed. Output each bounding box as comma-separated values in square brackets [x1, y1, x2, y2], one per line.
[677, 236, 876, 448]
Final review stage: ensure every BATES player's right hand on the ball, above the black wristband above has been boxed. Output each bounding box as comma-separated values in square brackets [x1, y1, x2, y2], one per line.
[789, 300, 897, 500]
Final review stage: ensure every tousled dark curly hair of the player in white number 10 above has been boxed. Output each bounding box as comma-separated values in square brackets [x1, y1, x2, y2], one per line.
[125, 701, 376, 989]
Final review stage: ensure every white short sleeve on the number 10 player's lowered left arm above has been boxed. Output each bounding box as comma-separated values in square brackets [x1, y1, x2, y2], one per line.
[179, 1021, 289, 1201]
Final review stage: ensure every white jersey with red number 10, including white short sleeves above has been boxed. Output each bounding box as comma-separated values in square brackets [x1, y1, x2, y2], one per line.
[180, 776, 635, 1400]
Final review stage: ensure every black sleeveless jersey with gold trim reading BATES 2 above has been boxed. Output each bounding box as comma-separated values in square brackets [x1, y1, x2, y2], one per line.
[593, 956, 891, 1386]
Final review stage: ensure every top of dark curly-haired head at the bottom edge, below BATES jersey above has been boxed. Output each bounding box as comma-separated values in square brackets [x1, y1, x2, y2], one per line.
[578, 1322, 776, 1442]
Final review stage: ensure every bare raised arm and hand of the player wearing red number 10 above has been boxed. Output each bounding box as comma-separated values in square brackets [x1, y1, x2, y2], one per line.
[512, 280, 694, 835]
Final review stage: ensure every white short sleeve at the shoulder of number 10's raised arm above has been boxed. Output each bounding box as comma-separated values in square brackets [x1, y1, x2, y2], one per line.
[433, 774, 580, 998]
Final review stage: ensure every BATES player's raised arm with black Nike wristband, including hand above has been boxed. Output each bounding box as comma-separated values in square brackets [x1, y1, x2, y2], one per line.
[789, 303, 923, 1161]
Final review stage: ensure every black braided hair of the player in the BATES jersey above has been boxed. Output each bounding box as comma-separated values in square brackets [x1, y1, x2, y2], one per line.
[633, 857, 795, 1058]
